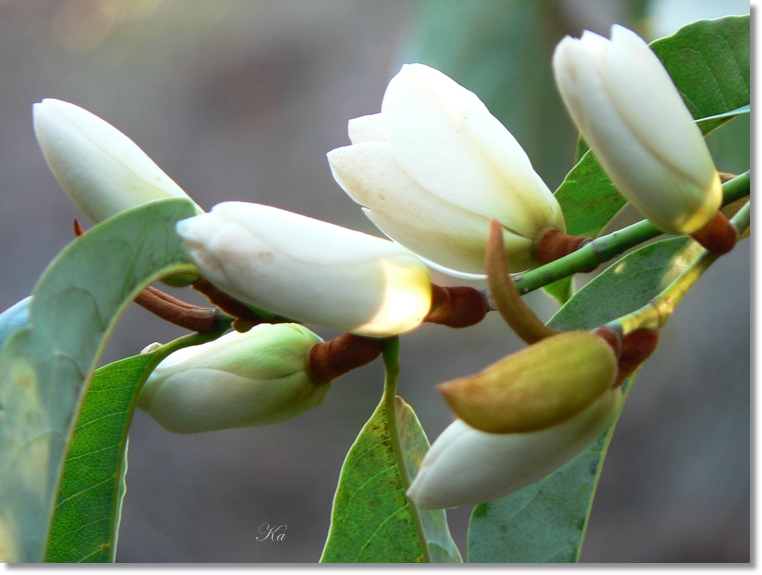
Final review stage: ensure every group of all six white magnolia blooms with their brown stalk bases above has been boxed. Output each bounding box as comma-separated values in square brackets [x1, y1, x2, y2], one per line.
[34, 22, 724, 508]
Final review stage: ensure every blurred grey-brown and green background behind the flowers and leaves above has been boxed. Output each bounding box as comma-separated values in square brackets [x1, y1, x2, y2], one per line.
[0, 0, 751, 563]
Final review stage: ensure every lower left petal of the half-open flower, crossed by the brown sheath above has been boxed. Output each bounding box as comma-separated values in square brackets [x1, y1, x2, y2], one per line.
[328, 142, 538, 274]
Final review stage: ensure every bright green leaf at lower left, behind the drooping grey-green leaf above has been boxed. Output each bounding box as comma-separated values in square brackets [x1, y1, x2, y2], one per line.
[45, 334, 218, 563]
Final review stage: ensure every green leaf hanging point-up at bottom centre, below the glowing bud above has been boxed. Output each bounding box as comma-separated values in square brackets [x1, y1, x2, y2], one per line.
[320, 340, 461, 563]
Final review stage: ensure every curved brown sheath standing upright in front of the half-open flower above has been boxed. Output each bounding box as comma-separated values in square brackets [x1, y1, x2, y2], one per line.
[485, 219, 558, 344]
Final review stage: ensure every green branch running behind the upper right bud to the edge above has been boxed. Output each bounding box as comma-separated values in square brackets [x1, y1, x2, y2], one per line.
[516, 170, 751, 295]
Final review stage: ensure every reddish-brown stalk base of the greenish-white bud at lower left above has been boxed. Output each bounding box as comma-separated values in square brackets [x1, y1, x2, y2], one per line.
[310, 333, 386, 383]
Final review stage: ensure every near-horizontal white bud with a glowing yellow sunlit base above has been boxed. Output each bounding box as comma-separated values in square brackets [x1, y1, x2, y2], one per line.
[177, 202, 431, 337]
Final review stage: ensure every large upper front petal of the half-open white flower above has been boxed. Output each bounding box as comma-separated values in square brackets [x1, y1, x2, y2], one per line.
[381, 64, 564, 239]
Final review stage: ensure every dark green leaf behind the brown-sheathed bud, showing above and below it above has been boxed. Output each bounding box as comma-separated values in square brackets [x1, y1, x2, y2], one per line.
[468, 238, 702, 563]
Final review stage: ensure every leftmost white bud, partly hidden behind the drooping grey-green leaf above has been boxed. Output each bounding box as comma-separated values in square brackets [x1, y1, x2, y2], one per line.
[33, 98, 203, 223]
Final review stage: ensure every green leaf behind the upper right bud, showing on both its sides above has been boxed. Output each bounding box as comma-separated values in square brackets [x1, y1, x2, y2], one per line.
[556, 16, 751, 241]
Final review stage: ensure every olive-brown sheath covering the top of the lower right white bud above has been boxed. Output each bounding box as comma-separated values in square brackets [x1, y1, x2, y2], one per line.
[438, 331, 617, 433]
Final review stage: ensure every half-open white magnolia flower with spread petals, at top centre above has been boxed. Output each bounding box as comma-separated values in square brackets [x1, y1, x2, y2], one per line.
[328, 64, 565, 276]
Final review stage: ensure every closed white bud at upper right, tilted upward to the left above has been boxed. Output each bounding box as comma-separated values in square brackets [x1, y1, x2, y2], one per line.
[553, 26, 722, 233]
